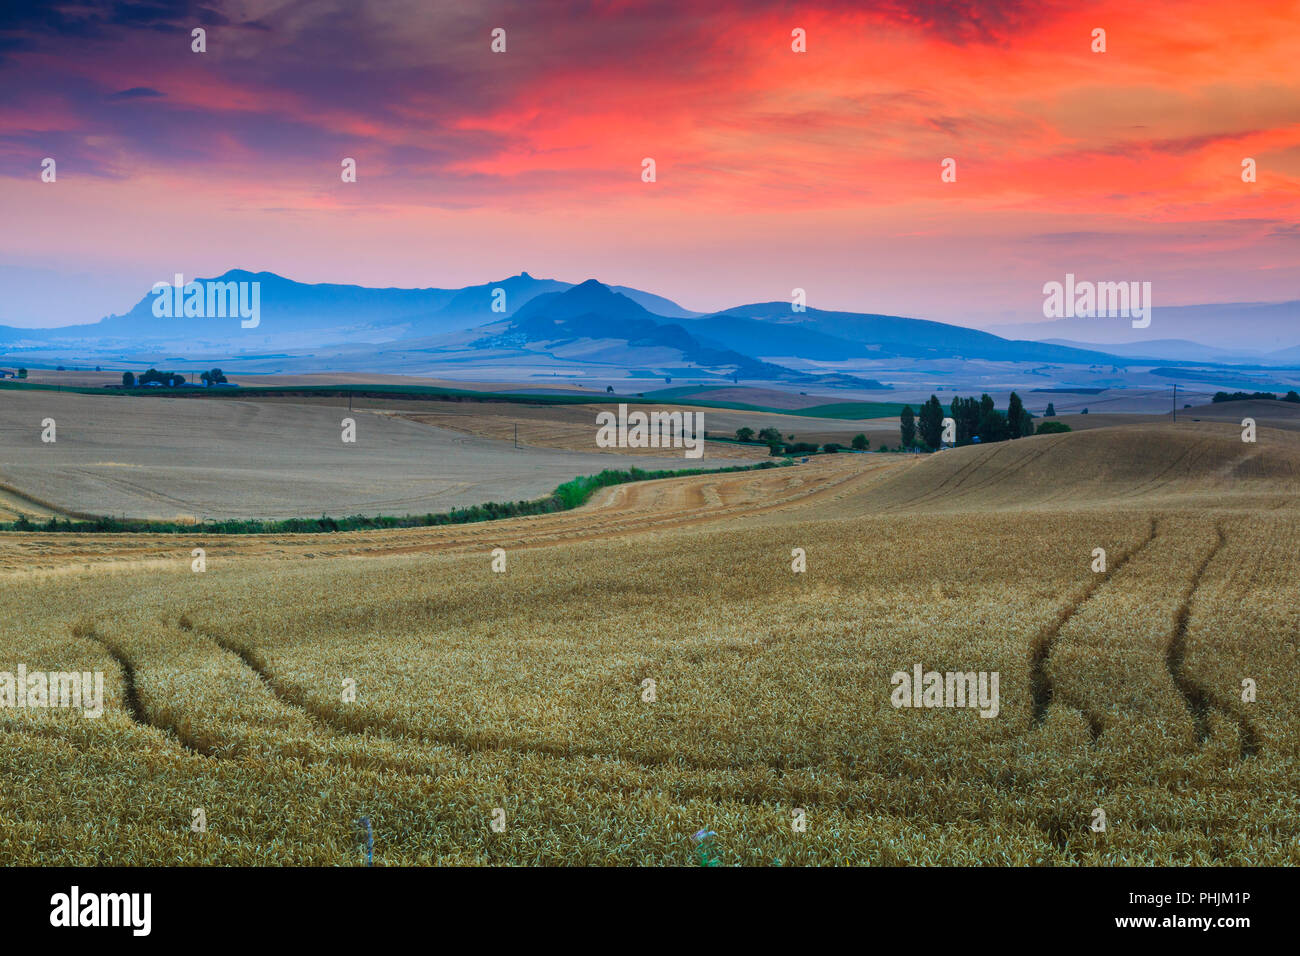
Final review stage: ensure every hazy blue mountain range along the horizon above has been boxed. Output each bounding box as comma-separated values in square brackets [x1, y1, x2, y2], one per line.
[0, 269, 1300, 389]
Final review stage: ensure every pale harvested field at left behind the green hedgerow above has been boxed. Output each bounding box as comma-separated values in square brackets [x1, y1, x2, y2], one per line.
[0, 392, 710, 520]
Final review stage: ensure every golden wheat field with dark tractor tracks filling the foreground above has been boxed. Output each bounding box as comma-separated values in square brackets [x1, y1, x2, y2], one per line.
[0, 420, 1300, 865]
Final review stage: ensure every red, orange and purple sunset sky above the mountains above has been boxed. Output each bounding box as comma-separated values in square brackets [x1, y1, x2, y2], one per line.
[0, 0, 1300, 328]
